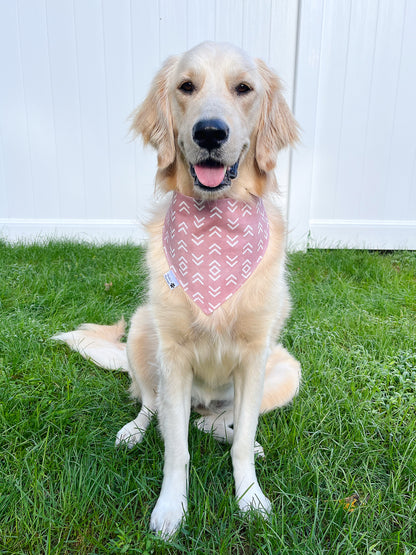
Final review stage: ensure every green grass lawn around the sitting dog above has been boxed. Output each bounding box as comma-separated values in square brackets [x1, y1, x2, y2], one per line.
[0, 243, 416, 555]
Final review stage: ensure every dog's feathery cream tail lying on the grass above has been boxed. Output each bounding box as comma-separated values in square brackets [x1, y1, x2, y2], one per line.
[51, 319, 129, 372]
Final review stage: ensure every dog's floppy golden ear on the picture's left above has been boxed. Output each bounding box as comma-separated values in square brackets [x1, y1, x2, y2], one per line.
[131, 57, 177, 169]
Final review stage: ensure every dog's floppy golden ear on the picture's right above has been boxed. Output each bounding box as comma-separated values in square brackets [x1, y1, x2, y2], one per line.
[256, 60, 298, 172]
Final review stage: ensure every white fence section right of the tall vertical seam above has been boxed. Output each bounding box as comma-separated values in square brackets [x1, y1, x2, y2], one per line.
[289, 0, 416, 248]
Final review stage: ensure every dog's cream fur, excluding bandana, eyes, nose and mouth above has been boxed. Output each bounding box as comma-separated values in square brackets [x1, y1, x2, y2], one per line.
[56, 43, 300, 536]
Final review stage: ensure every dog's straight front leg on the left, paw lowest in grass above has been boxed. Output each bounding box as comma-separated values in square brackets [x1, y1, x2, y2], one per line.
[150, 348, 192, 537]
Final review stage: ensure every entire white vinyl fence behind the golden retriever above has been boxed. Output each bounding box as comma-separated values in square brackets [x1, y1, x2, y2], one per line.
[0, 0, 416, 248]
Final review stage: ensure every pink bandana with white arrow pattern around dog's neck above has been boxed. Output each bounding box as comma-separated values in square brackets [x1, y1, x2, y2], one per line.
[163, 193, 269, 314]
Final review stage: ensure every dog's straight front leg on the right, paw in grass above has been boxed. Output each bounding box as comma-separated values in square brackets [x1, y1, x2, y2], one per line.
[231, 349, 271, 514]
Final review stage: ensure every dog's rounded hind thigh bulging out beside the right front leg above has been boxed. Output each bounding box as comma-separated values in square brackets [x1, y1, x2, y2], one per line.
[260, 344, 301, 413]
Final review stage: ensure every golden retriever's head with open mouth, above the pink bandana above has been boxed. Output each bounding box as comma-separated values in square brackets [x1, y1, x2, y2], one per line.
[132, 42, 297, 198]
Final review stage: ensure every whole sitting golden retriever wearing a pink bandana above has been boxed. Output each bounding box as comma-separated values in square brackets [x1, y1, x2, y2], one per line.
[55, 42, 301, 538]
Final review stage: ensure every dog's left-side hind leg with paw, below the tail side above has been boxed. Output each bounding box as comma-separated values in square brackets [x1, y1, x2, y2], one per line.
[116, 306, 157, 448]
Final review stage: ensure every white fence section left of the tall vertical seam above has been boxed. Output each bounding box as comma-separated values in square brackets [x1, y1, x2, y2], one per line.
[0, 0, 297, 243]
